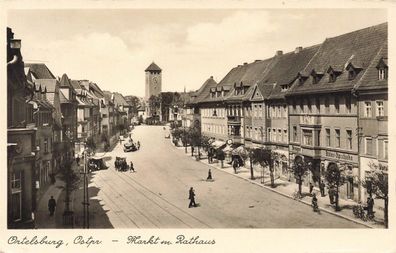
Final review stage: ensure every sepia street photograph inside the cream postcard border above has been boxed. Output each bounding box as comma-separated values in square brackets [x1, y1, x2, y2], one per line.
[5, 8, 390, 233]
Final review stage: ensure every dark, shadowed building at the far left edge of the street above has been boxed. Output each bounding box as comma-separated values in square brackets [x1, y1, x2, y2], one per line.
[7, 28, 36, 229]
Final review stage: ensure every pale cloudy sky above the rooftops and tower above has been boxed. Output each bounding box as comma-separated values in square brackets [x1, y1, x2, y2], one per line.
[7, 9, 387, 96]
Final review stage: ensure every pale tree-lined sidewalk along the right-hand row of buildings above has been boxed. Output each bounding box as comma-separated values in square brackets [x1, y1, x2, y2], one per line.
[172, 143, 385, 228]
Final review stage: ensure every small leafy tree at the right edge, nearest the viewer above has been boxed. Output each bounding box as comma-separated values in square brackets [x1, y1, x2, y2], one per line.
[362, 163, 388, 228]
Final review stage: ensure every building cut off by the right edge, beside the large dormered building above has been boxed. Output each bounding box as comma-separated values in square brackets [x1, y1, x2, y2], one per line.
[353, 39, 388, 200]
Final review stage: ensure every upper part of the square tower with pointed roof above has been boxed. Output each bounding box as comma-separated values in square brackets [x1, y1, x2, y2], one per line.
[144, 62, 162, 101]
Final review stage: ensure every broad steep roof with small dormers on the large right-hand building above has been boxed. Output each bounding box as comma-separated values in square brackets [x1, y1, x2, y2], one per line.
[287, 23, 388, 95]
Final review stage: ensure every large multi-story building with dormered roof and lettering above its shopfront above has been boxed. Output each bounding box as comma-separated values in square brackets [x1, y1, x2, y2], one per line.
[287, 24, 387, 201]
